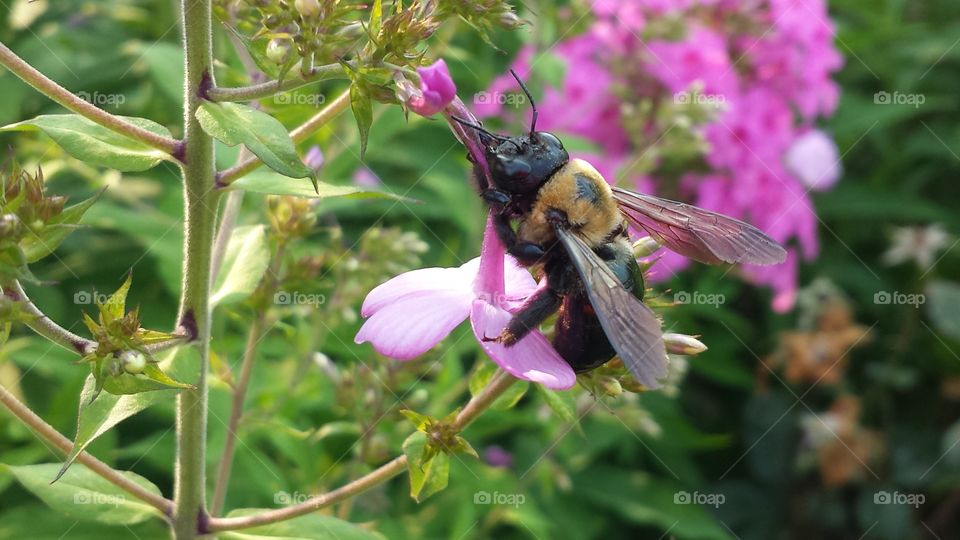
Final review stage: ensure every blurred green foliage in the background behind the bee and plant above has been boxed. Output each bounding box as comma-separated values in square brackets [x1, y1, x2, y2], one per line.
[0, 0, 960, 539]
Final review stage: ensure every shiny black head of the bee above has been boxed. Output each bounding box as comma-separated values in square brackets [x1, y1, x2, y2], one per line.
[487, 131, 570, 194]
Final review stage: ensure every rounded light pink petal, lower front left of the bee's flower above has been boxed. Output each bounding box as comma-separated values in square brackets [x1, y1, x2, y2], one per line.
[354, 290, 472, 360]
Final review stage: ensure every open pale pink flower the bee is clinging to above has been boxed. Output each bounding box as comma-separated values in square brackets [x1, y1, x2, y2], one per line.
[355, 214, 576, 390]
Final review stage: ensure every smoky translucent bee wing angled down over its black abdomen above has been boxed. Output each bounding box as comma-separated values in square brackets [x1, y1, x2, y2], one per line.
[557, 228, 667, 389]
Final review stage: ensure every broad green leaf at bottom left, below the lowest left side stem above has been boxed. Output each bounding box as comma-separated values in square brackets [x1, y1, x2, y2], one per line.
[4, 463, 163, 525]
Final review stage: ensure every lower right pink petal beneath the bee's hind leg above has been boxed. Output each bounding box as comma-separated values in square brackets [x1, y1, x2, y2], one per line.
[470, 300, 577, 390]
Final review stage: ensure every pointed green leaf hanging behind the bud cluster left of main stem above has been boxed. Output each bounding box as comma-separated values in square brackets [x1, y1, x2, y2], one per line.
[54, 349, 193, 480]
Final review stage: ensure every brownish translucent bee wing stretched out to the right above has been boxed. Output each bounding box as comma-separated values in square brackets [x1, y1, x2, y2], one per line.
[613, 187, 787, 264]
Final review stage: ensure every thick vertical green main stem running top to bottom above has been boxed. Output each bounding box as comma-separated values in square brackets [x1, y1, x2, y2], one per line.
[173, 0, 218, 540]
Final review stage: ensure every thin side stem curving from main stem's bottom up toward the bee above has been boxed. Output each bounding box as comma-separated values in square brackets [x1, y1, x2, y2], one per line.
[209, 371, 517, 532]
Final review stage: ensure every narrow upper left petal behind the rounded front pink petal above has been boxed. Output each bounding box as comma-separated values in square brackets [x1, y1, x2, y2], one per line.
[360, 258, 480, 317]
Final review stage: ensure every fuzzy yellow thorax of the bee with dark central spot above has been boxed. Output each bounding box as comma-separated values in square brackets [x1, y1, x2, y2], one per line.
[517, 159, 622, 246]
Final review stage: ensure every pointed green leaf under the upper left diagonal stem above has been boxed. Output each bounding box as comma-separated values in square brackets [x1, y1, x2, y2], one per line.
[0, 114, 173, 172]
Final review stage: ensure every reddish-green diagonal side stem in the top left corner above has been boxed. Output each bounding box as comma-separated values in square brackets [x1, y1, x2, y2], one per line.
[0, 43, 181, 158]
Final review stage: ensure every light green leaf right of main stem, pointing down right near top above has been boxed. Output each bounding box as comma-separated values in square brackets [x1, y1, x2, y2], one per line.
[197, 101, 313, 178]
